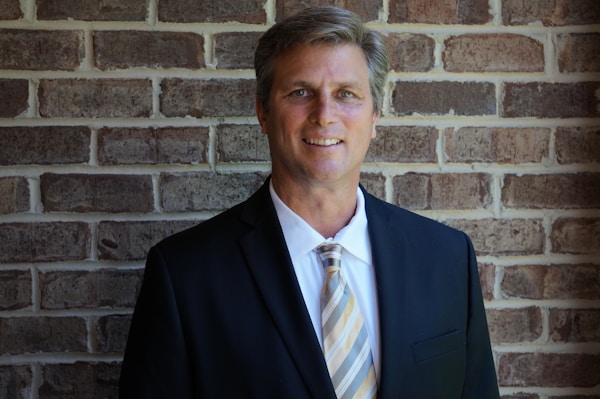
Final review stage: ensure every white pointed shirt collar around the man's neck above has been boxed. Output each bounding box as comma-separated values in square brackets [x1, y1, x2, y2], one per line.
[269, 183, 372, 264]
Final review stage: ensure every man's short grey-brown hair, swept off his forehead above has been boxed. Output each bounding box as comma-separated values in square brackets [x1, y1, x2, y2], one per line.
[254, 6, 389, 113]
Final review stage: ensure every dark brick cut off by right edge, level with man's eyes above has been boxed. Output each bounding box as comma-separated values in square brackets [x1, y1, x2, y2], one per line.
[502, 82, 600, 118]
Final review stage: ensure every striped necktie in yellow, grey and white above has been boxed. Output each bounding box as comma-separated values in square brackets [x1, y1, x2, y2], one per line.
[316, 243, 377, 399]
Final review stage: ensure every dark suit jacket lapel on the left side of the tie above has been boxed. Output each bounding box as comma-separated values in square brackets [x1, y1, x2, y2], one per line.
[240, 183, 335, 398]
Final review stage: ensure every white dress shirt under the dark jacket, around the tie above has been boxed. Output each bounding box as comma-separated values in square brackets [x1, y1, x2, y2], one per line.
[269, 184, 380, 378]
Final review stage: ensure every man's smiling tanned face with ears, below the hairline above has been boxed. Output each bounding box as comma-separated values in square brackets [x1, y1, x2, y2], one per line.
[256, 44, 379, 191]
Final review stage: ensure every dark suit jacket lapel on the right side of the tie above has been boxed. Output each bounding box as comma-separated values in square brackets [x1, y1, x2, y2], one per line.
[363, 190, 407, 399]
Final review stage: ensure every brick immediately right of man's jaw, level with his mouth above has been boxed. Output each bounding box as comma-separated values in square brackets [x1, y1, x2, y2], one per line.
[365, 126, 439, 163]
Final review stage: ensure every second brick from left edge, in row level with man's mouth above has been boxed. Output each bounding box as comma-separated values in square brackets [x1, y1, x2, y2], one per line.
[98, 127, 209, 165]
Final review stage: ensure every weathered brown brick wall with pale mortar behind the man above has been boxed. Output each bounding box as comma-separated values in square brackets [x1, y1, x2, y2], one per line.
[0, 0, 600, 399]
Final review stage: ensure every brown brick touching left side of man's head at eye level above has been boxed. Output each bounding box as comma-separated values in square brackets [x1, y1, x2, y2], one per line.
[160, 78, 256, 118]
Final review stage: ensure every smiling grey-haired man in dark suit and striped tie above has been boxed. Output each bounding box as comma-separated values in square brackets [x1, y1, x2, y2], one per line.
[120, 7, 498, 399]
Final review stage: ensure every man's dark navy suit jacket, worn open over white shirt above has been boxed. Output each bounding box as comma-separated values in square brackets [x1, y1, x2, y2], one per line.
[120, 184, 498, 399]
